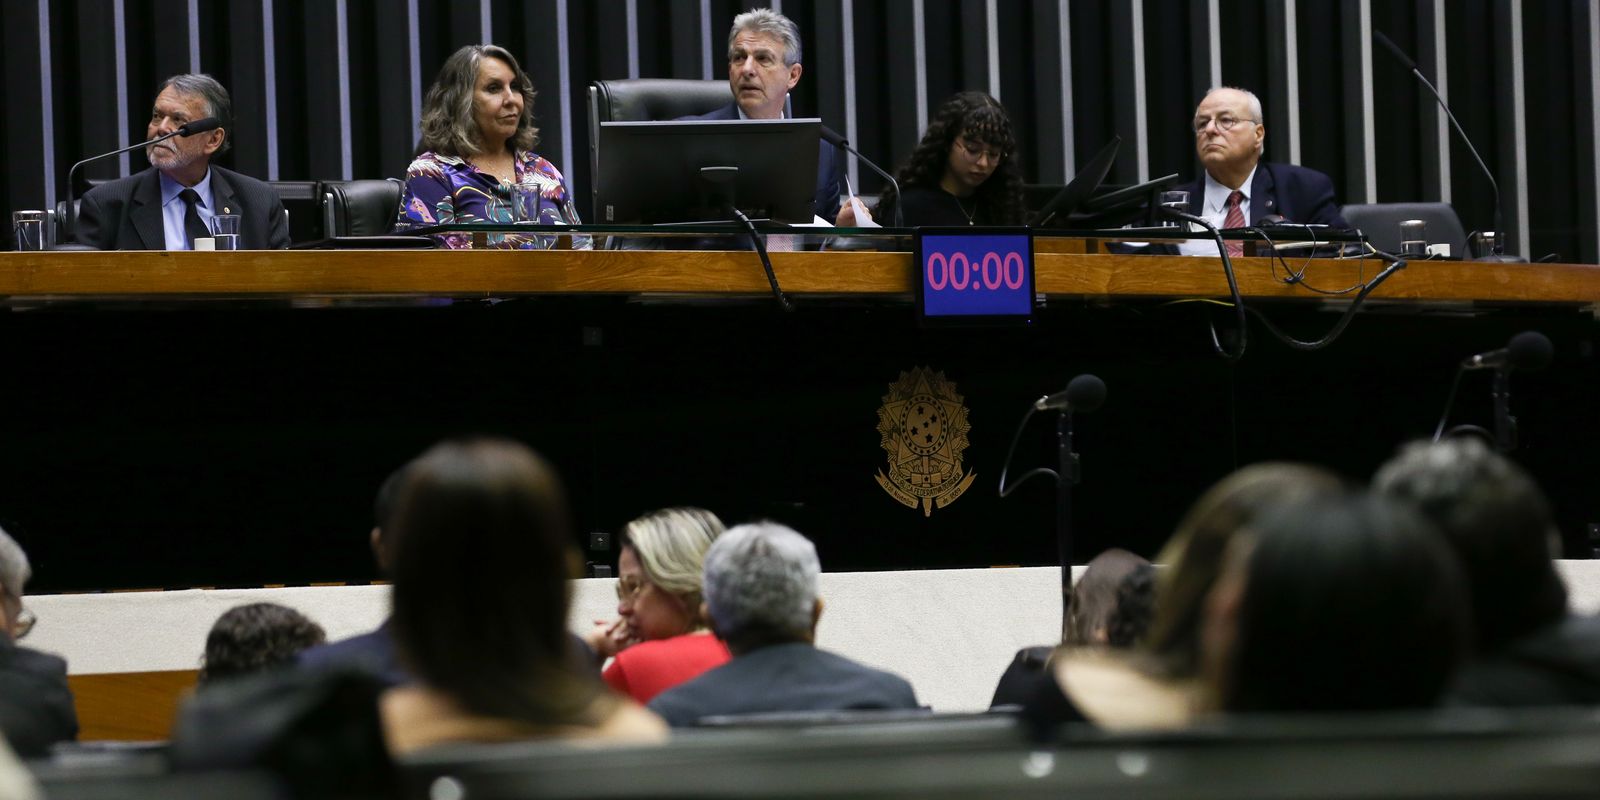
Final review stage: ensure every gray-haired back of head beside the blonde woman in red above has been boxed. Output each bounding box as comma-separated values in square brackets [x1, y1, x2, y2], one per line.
[706, 522, 822, 653]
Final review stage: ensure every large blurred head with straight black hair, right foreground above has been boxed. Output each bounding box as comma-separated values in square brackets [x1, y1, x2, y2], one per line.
[1206, 494, 1470, 712]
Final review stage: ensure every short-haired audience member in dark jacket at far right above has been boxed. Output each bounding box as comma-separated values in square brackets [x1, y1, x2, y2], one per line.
[1373, 438, 1600, 706]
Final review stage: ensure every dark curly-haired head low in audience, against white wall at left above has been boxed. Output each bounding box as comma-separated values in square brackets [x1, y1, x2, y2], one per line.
[200, 603, 328, 683]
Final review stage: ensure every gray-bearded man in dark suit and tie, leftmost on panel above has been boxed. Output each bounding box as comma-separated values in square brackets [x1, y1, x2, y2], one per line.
[74, 74, 290, 250]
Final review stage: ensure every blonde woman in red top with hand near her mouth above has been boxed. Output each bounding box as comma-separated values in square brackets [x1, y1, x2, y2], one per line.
[589, 509, 731, 702]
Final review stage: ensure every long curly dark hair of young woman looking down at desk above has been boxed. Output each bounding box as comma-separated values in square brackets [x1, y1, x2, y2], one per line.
[875, 91, 1022, 226]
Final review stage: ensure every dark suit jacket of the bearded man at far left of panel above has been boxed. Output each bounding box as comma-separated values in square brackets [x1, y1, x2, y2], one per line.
[77, 165, 290, 250]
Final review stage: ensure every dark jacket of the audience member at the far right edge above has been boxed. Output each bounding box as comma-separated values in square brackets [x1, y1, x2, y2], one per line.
[1450, 616, 1600, 707]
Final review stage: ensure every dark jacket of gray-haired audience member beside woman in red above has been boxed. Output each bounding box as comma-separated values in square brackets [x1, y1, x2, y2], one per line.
[650, 642, 918, 728]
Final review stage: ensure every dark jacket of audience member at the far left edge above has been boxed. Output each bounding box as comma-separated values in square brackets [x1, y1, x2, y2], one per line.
[0, 637, 78, 758]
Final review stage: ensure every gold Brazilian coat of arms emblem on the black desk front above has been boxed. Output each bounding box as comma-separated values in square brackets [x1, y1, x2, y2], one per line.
[875, 366, 978, 517]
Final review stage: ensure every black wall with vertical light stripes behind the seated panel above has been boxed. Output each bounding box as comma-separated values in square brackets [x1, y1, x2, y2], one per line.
[0, 0, 1600, 262]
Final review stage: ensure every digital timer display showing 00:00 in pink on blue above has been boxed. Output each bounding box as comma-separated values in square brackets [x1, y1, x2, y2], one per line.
[915, 227, 1034, 322]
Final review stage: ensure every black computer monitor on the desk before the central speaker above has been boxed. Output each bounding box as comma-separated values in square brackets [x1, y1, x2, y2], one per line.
[594, 118, 822, 224]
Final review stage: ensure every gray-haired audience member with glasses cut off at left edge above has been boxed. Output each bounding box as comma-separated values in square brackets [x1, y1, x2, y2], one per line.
[0, 531, 78, 758]
